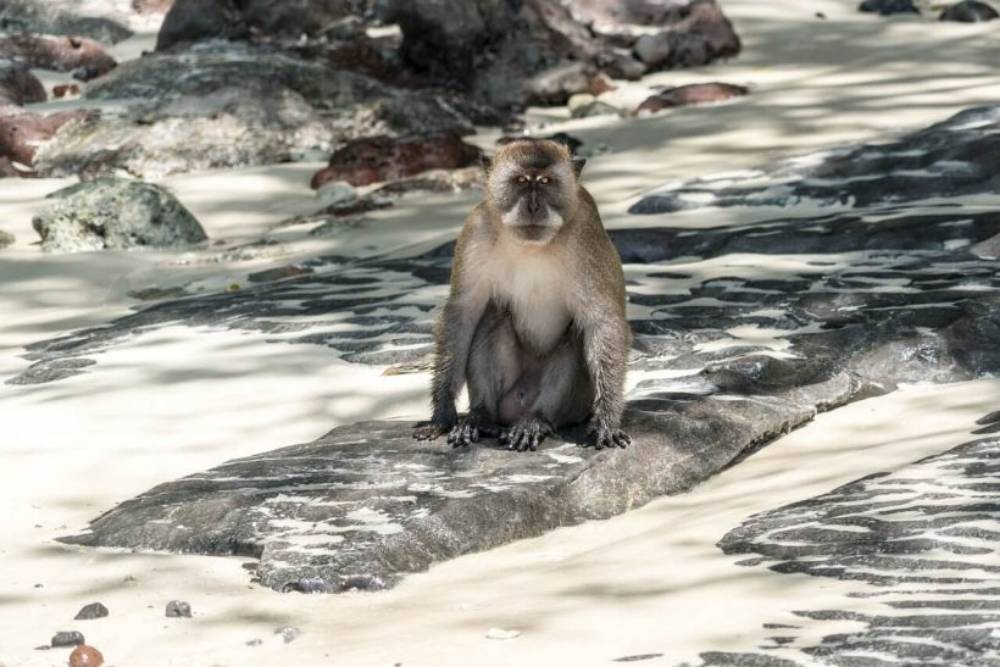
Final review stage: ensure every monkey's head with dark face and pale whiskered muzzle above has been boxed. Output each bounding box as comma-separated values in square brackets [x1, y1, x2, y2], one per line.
[486, 137, 584, 244]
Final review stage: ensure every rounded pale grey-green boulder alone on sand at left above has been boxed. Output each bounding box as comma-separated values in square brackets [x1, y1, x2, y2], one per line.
[32, 178, 208, 252]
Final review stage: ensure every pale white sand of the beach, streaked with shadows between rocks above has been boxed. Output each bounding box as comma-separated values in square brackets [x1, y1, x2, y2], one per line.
[0, 0, 1000, 667]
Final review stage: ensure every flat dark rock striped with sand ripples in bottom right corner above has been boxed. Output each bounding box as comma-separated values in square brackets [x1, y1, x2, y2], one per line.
[702, 437, 1000, 667]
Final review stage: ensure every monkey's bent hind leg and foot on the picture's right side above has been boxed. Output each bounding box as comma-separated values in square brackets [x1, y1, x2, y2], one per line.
[501, 330, 594, 451]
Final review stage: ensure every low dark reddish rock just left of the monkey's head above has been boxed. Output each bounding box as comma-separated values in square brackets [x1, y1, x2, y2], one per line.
[312, 134, 482, 188]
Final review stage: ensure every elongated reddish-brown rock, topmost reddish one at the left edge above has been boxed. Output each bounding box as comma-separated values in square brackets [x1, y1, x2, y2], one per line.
[0, 35, 117, 81]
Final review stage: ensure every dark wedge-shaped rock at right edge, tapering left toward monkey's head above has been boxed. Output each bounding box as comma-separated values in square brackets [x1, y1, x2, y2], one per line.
[629, 106, 1000, 214]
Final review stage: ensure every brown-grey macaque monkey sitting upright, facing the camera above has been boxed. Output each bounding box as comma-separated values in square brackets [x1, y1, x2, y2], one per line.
[414, 138, 632, 452]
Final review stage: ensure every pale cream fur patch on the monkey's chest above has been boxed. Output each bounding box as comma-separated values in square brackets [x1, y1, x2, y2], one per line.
[493, 261, 573, 352]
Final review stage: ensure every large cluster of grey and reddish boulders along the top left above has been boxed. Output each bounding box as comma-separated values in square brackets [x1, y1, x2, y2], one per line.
[0, 0, 740, 182]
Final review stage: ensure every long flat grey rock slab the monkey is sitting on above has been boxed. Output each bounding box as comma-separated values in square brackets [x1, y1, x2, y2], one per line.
[60, 284, 1000, 592]
